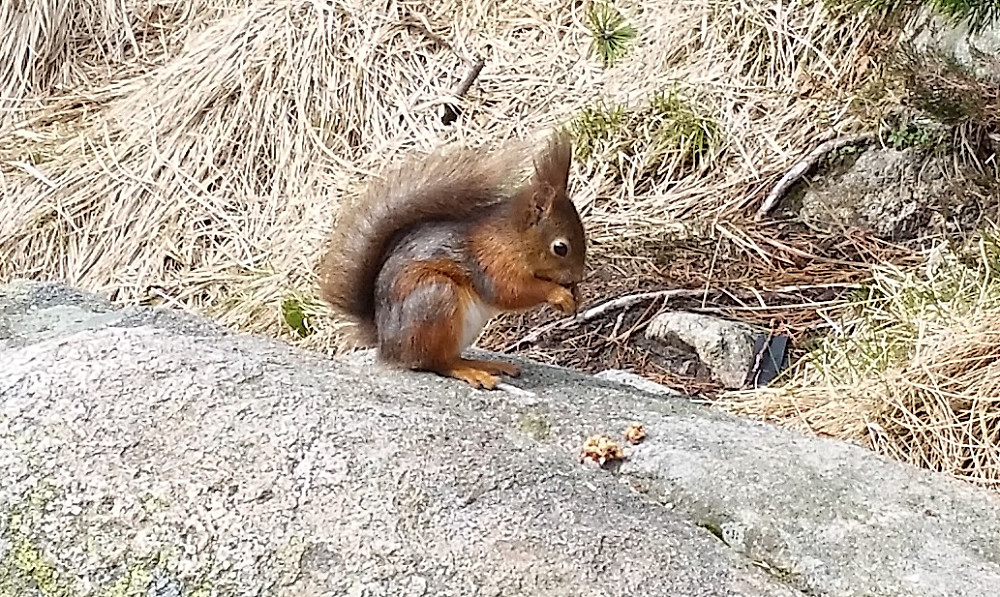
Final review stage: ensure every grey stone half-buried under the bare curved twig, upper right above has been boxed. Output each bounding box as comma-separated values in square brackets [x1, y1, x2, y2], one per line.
[799, 148, 975, 240]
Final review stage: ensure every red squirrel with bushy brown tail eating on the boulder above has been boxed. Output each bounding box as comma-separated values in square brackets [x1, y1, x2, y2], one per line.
[319, 132, 586, 389]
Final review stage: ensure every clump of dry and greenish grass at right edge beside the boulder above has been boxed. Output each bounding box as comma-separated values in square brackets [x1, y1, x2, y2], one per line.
[719, 229, 1000, 488]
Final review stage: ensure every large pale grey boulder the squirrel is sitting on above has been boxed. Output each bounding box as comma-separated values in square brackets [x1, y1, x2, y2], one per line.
[0, 284, 1000, 597]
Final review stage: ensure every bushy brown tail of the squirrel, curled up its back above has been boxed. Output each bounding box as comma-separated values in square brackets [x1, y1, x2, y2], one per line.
[319, 141, 520, 345]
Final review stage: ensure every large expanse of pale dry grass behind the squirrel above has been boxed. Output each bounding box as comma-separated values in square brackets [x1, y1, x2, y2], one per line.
[0, 0, 888, 347]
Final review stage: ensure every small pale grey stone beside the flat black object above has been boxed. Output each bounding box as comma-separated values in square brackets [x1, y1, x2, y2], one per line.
[646, 311, 759, 388]
